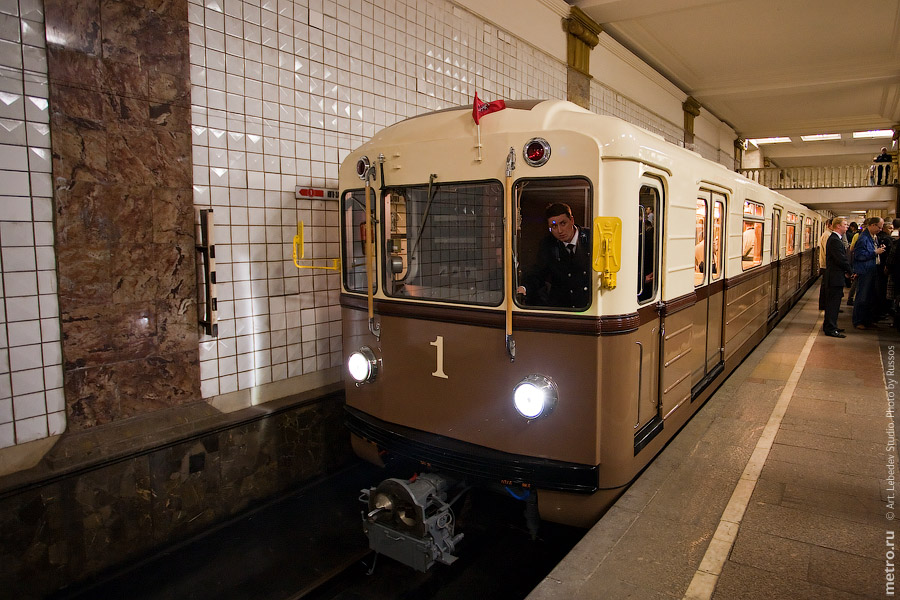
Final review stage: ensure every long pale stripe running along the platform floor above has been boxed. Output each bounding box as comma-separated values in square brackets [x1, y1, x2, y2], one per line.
[684, 308, 823, 600]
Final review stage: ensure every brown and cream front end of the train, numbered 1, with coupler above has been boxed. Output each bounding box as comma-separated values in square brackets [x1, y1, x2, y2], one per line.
[340, 98, 632, 570]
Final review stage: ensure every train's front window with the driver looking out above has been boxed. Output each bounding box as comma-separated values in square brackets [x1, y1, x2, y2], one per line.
[513, 178, 595, 310]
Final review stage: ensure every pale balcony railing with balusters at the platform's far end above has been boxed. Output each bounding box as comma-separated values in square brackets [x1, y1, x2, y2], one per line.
[738, 159, 897, 190]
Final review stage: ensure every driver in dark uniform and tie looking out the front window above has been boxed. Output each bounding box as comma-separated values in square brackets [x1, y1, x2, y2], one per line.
[516, 202, 591, 308]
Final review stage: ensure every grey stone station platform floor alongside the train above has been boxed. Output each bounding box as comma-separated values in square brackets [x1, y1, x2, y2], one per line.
[528, 286, 900, 600]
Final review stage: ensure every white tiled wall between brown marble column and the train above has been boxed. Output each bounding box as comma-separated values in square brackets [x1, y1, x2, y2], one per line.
[189, 0, 566, 398]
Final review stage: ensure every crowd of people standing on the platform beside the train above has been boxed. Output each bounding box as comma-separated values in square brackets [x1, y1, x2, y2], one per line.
[819, 217, 900, 338]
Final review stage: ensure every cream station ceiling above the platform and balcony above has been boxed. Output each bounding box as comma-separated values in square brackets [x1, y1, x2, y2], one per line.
[567, 0, 900, 167]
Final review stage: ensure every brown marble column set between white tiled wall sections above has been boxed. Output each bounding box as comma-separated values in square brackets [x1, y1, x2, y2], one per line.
[45, 0, 200, 430]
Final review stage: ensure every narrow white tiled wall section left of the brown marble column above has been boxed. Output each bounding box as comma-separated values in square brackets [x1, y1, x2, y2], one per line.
[0, 0, 66, 448]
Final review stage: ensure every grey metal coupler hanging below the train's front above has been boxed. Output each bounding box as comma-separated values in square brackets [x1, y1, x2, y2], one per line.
[359, 473, 464, 573]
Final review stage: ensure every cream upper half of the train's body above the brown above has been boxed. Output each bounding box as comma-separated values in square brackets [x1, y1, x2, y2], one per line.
[340, 101, 821, 315]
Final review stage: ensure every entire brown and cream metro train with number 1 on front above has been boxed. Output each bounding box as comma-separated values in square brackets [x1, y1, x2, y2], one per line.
[340, 100, 824, 570]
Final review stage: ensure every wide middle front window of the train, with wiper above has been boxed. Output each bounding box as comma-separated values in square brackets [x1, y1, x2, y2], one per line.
[382, 181, 503, 306]
